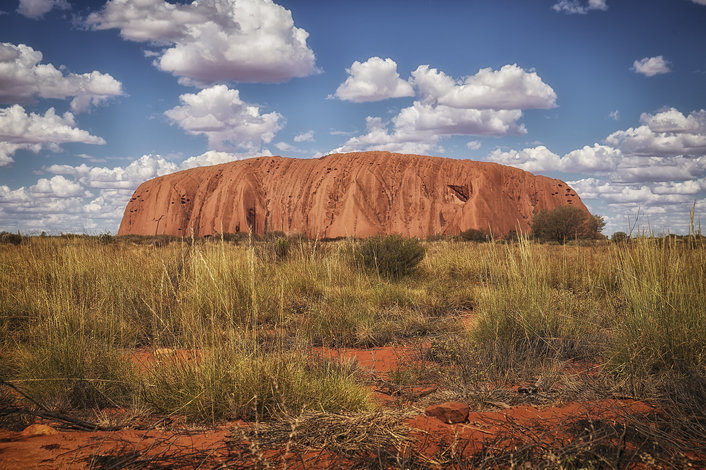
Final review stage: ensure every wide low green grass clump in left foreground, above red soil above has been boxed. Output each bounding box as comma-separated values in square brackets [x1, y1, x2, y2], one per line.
[144, 348, 372, 422]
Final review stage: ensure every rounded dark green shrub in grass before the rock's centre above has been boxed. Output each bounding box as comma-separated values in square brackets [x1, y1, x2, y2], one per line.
[358, 235, 426, 279]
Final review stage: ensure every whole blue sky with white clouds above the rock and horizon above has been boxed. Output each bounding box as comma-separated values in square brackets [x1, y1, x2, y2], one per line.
[0, 0, 706, 235]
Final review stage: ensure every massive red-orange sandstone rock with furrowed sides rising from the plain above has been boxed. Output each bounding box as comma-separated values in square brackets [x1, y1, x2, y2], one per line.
[118, 152, 587, 239]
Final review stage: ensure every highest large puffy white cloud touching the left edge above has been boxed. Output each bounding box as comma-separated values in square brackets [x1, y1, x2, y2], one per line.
[0, 42, 123, 112]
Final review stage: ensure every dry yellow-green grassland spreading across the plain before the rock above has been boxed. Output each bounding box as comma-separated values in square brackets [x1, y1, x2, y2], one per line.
[0, 229, 706, 467]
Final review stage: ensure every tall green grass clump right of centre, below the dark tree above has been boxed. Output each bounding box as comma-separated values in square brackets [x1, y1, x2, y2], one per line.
[472, 239, 602, 367]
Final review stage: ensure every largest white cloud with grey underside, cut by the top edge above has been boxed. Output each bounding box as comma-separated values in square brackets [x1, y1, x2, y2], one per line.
[86, 0, 316, 87]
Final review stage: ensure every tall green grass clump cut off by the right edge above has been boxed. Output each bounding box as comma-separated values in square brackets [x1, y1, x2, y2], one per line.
[610, 237, 706, 376]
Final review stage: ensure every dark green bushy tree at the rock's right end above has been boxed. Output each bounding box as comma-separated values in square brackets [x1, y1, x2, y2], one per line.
[531, 206, 605, 244]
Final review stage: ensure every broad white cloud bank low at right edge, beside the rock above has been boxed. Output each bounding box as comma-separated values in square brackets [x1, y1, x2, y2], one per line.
[487, 108, 706, 237]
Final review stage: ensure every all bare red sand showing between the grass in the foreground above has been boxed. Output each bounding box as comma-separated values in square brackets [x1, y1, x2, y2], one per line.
[0, 346, 672, 468]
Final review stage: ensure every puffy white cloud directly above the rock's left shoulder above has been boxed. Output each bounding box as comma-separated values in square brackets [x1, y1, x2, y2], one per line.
[164, 85, 284, 150]
